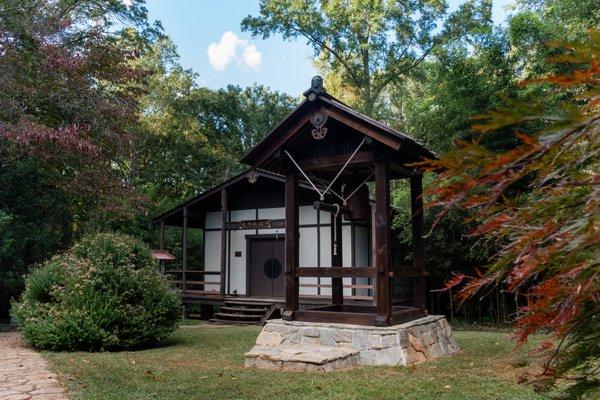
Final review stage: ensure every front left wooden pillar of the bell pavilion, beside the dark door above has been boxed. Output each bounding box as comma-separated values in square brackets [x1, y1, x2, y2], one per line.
[283, 170, 300, 320]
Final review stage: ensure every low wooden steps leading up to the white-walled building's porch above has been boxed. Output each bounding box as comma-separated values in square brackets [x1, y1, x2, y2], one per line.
[210, 300, 279, 325]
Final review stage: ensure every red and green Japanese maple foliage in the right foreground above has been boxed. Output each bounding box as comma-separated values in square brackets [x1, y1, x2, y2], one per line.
[425, 31, 600, 398]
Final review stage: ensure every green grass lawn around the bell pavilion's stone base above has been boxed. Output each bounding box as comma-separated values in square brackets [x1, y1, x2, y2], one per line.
[44, 323, 541, 400]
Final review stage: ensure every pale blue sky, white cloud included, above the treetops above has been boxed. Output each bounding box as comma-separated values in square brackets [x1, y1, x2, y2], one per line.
[144, 0, 510, 96]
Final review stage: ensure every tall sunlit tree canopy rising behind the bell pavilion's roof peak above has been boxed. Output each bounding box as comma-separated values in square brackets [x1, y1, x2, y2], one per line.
[242, 0, 492, 116]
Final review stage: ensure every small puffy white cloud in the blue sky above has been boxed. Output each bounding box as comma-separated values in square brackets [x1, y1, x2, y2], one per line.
[206, 31, 262, 71]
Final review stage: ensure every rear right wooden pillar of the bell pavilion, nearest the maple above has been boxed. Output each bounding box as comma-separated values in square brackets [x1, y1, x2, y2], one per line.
[410, 173, 427, 309]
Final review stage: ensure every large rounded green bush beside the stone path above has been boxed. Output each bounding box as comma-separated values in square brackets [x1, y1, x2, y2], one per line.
[13, 234, 181, 351]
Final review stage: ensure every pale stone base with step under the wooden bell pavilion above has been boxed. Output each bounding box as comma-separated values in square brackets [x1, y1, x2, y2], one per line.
[246, 315, 459, 371]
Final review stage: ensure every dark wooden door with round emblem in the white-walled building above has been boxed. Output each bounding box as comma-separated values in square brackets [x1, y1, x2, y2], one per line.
[248, 237, 285, 297]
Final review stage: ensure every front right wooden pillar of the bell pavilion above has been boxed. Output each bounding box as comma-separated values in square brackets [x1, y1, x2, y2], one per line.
[374, 160, 392, 326]
